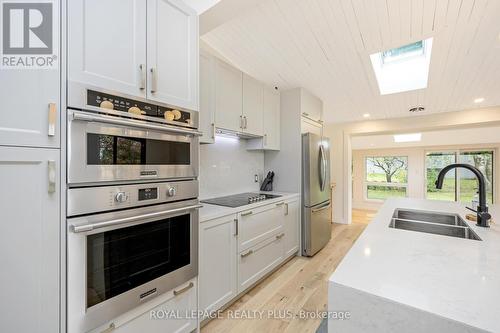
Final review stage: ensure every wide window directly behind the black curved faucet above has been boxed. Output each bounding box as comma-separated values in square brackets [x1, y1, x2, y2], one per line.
[426, 150, 494, 204]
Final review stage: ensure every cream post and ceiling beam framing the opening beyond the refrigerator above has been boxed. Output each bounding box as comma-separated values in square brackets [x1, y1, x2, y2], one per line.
[324, 108, 500, 223]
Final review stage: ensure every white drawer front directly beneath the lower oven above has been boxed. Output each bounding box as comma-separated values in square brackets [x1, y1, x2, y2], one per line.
[91, 279, 198, 333]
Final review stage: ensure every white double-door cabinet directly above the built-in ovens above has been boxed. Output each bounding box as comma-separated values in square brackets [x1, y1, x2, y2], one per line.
[68, 0, 198, 110]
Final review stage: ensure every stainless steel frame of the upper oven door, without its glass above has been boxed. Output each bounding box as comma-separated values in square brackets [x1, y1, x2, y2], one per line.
[68, 110, 199, 186]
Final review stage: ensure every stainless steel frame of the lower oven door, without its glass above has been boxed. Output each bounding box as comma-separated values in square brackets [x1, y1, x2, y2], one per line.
[68, 199, 199, 332]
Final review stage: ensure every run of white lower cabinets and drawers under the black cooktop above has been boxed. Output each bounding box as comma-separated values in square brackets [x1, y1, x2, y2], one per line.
[198, 198, 300, 311]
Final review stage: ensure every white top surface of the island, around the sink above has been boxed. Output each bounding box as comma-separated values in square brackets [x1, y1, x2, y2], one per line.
[330, 199, 500, 332]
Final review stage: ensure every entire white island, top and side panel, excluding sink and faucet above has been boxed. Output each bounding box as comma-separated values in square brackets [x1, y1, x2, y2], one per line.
[328, 198, 500, 332]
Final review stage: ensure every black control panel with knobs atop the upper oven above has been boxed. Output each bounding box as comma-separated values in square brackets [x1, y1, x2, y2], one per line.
[87, 90, 195, 127]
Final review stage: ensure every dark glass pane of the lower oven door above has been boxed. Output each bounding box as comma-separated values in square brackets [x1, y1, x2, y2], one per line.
[87, 214, 191, 307]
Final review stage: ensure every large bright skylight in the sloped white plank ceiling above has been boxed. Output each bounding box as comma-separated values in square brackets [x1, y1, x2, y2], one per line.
[370, 38, 432, 95]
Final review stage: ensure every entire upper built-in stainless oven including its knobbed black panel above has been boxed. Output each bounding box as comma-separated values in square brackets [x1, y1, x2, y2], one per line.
[68, 92, 201, 187]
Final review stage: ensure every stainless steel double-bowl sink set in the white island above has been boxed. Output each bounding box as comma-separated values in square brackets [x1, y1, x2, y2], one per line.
[389, 208, 481, 241]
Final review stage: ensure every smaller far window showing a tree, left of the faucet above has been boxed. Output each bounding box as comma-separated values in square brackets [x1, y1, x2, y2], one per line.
[365, 156, 408, 200]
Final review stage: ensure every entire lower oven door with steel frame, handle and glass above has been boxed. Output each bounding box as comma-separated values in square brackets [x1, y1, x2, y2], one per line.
[68, 199, 201, 332]
